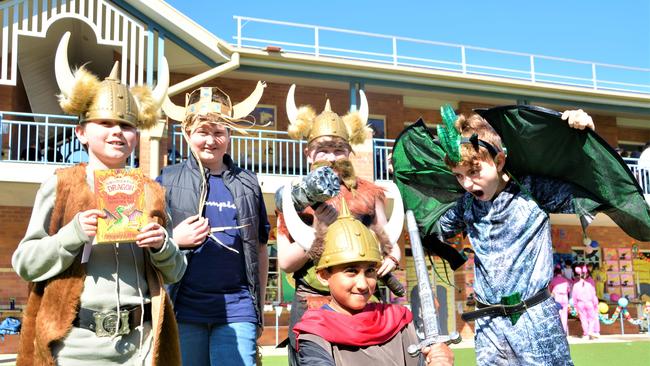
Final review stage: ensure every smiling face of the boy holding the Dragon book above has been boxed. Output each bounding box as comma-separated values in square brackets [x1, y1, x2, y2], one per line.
[75, 120, 138, 169]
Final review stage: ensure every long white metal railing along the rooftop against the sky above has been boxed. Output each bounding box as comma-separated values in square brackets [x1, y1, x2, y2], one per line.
[233, 16, 650, 94]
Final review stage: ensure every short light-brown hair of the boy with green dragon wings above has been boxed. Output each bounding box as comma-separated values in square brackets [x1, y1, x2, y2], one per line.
[445, 114, 503, 168]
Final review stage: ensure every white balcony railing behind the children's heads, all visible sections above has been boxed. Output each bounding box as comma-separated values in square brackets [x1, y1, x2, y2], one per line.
[0, 111, 650, 194]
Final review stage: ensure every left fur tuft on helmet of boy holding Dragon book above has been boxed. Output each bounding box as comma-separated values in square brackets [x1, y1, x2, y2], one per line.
[58, 66, 101, 116]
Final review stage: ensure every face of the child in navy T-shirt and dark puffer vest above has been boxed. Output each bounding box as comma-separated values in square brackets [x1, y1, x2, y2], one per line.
[190, 122, 230, 166]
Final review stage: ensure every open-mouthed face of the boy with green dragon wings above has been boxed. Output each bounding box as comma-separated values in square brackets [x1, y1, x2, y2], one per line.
[451, 153, 506, 201]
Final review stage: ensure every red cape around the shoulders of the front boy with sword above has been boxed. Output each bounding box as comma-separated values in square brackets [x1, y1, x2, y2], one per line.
[293, 303, 413, 350]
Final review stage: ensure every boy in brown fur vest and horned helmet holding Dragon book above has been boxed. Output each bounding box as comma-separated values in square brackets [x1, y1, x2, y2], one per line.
[12, 33, 186, 366]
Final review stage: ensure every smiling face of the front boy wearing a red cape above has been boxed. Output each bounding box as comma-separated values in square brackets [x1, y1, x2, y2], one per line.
[317, 262, 377, 315]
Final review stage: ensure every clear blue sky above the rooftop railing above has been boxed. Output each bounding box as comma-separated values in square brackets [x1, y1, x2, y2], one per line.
[168, 0, 650, 68]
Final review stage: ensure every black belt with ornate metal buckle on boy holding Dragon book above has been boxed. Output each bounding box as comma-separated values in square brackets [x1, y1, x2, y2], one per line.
[72, 303, 151, 337]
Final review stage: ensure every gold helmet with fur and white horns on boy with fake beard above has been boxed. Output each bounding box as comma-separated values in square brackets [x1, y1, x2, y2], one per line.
[286, 84, 372, 145]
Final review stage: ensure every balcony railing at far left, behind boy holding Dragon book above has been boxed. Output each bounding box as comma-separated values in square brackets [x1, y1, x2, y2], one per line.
[0, 111, 136, 167]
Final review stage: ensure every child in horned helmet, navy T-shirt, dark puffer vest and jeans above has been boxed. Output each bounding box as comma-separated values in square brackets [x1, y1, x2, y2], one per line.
[157, 82, 269, 366]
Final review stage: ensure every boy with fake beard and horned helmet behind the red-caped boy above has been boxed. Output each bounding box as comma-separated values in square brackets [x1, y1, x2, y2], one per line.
[277, 85, 404, 365]
